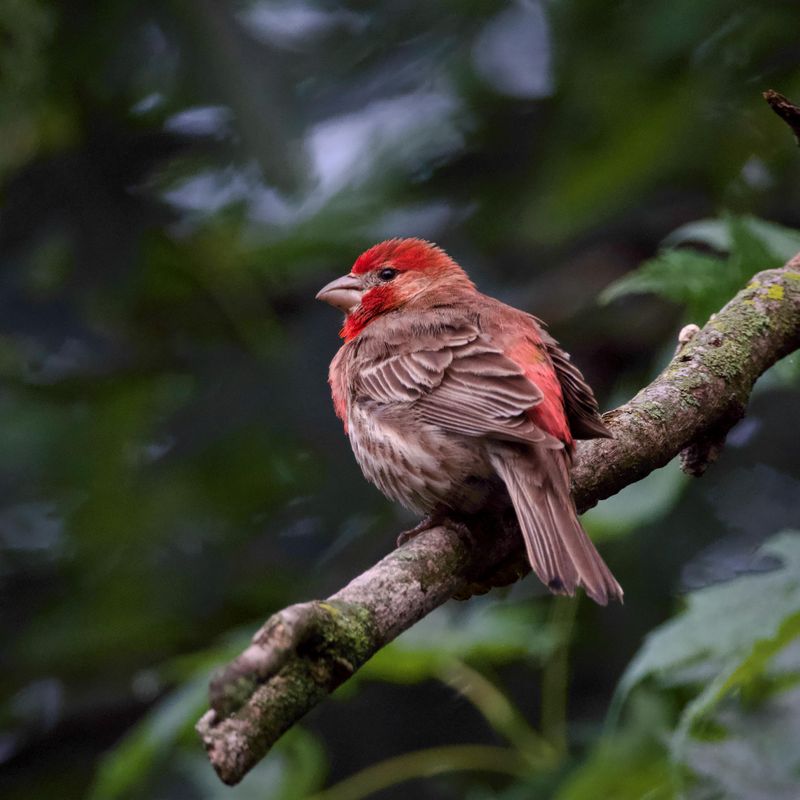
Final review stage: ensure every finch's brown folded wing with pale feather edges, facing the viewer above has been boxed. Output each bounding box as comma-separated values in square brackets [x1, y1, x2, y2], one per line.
[356, 325, 562, 447]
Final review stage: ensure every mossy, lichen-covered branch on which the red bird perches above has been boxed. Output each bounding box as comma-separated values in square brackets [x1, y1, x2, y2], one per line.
[197, 255, 800, 784]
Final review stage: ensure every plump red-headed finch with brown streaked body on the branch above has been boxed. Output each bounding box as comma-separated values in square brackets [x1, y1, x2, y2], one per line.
[317, 239, 622, 605]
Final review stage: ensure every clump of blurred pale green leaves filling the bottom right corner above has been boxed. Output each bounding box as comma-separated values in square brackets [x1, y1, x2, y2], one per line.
[558, 531, 800, 800]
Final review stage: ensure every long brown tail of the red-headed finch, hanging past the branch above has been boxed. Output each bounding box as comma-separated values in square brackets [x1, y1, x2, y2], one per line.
[491, 448, 622, 605]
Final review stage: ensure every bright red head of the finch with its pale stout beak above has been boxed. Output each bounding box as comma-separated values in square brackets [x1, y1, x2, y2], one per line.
[317, 239, 474, 342]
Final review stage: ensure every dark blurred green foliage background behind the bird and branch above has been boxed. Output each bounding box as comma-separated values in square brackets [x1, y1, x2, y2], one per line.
[0, 0, 800, 800]
